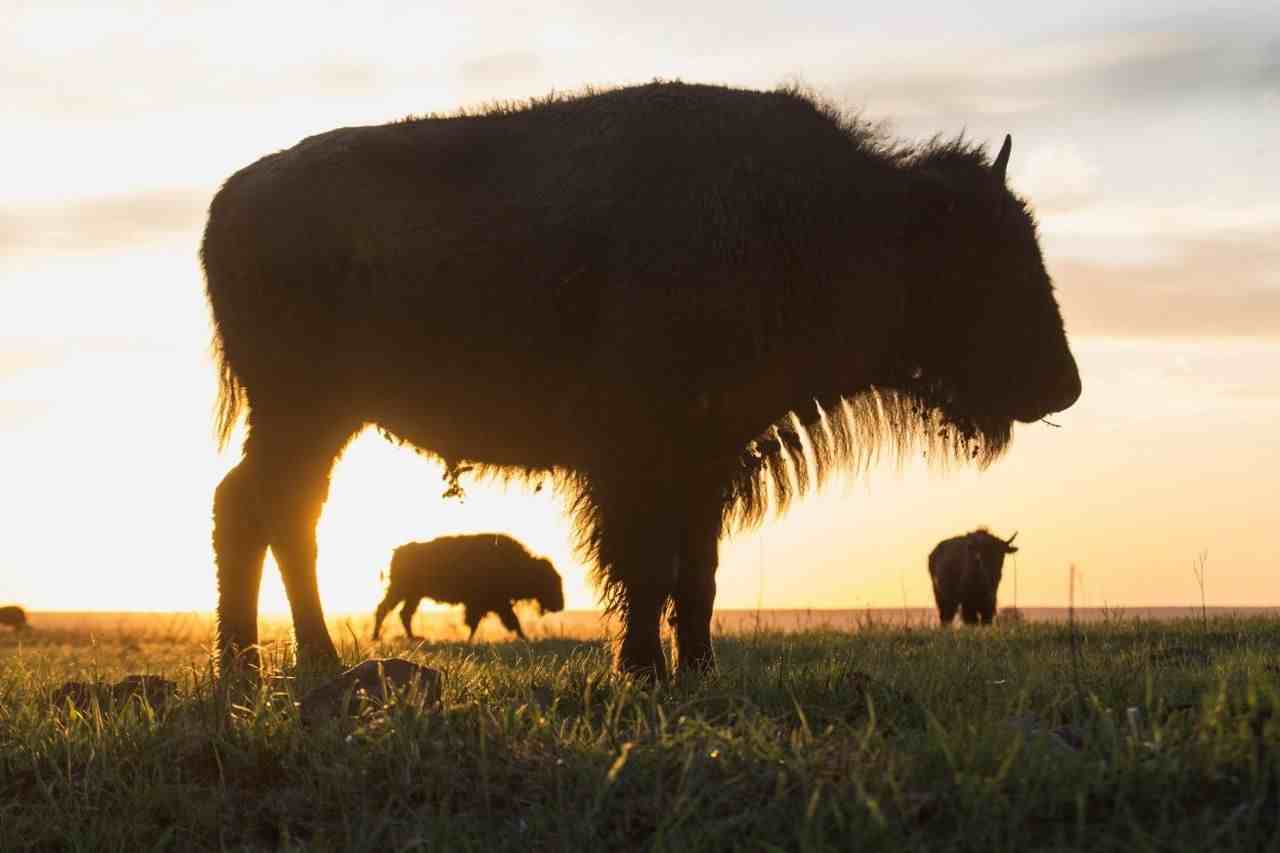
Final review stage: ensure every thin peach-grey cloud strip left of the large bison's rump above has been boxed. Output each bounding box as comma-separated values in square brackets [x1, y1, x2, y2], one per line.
[0, 188, 204, 252]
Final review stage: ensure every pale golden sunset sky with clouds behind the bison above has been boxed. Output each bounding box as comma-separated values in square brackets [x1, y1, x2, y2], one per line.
[0, 0, 1280, 611]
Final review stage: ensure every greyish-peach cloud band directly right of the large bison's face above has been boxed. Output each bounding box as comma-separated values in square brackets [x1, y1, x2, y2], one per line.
[1050, 231, 1280, 341]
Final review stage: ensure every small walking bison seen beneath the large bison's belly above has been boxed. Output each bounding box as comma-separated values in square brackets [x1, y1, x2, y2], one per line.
[374, 533, 564, 640]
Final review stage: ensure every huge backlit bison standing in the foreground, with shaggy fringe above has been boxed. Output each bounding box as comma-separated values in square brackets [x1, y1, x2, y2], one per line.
[201, 82, 1080, 678]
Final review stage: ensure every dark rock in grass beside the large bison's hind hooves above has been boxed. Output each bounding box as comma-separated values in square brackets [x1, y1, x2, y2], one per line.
[298, 657, 443, 724]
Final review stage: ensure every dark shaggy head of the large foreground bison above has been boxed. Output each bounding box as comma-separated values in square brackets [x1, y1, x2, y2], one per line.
[892, 136, 1080, 456]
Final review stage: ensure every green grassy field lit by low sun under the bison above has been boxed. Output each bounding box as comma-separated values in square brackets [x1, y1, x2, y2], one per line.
[0, 617, 1280, 850]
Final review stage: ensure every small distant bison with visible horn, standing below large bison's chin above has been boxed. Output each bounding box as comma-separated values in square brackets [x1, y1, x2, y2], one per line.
[929, 528, 1018, 628]
